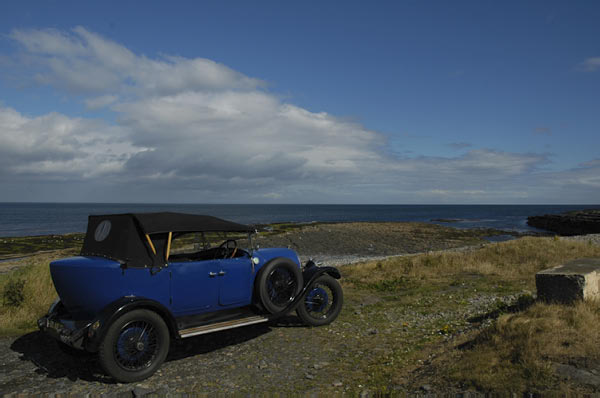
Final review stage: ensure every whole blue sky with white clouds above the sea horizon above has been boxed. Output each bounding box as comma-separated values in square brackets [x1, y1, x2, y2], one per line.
[0, 0, 600, 204]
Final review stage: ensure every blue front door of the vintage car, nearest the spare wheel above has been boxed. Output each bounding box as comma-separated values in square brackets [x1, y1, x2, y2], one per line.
[216, 255, 254, 307]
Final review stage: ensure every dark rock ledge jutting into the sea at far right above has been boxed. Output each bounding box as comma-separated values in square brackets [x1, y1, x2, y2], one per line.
[527, 209, 600, 235]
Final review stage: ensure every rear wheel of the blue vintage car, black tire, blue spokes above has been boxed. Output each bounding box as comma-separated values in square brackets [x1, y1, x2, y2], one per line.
[98, 309, 170, 383]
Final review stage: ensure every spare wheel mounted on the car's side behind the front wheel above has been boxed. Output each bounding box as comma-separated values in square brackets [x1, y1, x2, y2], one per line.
[257, 257, 302, 314]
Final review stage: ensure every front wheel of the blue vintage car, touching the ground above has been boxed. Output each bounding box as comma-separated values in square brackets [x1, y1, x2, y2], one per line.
[296, 275, 344, 326]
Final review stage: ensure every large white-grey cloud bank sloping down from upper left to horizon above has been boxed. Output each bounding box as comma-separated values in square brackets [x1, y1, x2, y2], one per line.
[0, 27, 600, 203]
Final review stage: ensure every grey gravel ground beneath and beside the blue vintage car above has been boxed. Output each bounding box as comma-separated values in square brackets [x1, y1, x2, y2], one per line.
[0, 295, 516, 397]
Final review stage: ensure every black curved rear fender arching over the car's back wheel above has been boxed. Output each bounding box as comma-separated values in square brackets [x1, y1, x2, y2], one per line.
[85, 296, 179, 352]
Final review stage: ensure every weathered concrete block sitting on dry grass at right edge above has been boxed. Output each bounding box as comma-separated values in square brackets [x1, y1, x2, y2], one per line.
[535, 258, 600, 304]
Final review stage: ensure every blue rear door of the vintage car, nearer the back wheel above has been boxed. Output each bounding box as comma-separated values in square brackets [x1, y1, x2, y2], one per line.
[169, 260, 219, 316]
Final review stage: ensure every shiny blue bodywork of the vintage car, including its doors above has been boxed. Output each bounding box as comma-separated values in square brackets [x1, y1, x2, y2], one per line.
[50, 248, 300, 319]
